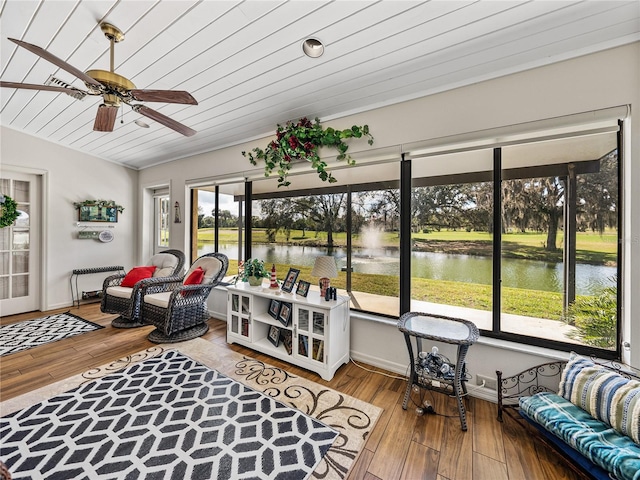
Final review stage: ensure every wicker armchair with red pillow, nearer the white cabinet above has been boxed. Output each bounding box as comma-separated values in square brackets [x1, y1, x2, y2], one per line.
[141, 253, 229, 343]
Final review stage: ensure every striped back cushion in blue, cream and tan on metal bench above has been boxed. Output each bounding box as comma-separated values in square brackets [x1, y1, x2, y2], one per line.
[558, 353, 640, 443]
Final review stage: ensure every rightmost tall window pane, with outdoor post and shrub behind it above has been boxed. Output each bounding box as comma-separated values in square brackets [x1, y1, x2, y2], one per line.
[500, 133, 619, 351]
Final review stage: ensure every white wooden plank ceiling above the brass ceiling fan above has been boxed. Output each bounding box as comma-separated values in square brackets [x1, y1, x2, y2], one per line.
[0, 0, 640, 169]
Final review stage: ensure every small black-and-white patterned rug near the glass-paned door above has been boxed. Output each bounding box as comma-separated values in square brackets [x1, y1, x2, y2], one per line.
[0, 312, 104, 356]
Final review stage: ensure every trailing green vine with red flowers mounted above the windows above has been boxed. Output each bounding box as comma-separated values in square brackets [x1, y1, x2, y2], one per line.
[242, 118, 373, 187]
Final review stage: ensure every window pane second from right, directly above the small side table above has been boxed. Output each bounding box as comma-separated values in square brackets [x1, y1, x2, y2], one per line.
[411, 149, 494, 330]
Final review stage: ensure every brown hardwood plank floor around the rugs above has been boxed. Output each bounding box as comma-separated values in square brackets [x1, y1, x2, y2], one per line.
[0, 303, 581, 480]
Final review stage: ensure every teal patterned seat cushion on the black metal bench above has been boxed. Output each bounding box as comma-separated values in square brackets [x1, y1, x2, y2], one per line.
[520, 392, 640, 480]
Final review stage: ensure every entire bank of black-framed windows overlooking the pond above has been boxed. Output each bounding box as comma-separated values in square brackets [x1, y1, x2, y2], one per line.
[192, 126, 622, 357]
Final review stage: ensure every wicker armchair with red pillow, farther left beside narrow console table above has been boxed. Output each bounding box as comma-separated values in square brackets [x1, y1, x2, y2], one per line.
[100, 250, 185, 328]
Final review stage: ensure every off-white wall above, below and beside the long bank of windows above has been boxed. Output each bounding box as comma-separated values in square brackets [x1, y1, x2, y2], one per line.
[140, 43, 640, 386]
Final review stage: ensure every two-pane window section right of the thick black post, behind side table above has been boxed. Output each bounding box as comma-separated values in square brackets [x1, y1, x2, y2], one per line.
[404, 132, 621, 356]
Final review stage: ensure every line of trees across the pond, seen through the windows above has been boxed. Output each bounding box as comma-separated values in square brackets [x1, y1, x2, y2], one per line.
[198, 151, 619, 251]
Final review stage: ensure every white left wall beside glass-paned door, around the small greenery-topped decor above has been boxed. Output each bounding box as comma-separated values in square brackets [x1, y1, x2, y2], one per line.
[0, 127, 138, 310]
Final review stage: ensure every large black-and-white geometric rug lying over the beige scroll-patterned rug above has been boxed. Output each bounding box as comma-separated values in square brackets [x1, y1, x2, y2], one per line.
[0, 350, 338, 480]
